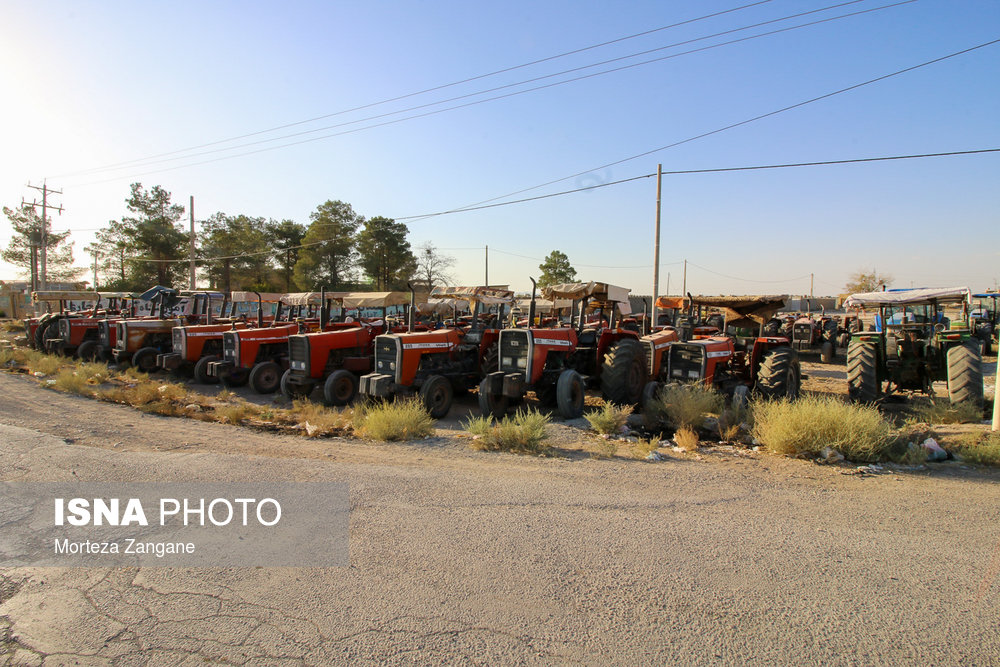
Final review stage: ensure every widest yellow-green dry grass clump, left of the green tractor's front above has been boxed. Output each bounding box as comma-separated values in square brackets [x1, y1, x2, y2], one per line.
[753, 396, 895, 461]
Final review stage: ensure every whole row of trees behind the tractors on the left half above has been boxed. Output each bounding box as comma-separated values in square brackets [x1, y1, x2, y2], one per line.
[0, 183, 454, 292]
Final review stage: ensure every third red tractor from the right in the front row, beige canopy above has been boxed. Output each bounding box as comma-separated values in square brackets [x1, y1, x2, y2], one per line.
[360, 287, 514, 419]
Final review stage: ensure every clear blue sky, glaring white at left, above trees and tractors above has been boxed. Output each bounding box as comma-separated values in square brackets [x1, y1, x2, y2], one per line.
[0, 0, 1000, 295]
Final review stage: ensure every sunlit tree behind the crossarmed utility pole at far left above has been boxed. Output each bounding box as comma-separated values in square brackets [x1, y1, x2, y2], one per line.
[0, 205, 86, 283]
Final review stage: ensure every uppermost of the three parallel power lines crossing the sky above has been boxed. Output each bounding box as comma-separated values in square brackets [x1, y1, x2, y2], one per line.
[50, 0, 776, 177]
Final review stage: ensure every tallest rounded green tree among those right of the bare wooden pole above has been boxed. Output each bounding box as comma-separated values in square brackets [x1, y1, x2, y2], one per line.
[293, 201, 364, 290]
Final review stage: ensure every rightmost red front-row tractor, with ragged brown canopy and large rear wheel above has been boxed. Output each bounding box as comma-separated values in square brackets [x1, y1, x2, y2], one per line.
[643, 296, 801, 405]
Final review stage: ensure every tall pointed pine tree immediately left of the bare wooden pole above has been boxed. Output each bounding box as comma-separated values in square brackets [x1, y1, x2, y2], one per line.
[112, 183, 190, 290]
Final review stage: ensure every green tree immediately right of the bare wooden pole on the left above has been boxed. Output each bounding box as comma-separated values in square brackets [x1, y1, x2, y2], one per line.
[199, 212, 272, 292]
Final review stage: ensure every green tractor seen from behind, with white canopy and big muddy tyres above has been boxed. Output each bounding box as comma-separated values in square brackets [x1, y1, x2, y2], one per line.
[845, 287, 983, 407]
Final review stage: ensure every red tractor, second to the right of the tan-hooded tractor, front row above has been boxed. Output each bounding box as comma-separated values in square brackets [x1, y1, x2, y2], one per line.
[207, 292, 335, 394]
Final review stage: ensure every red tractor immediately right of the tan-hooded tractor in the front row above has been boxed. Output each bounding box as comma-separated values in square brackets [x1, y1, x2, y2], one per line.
[156, 292, 281, 384]
